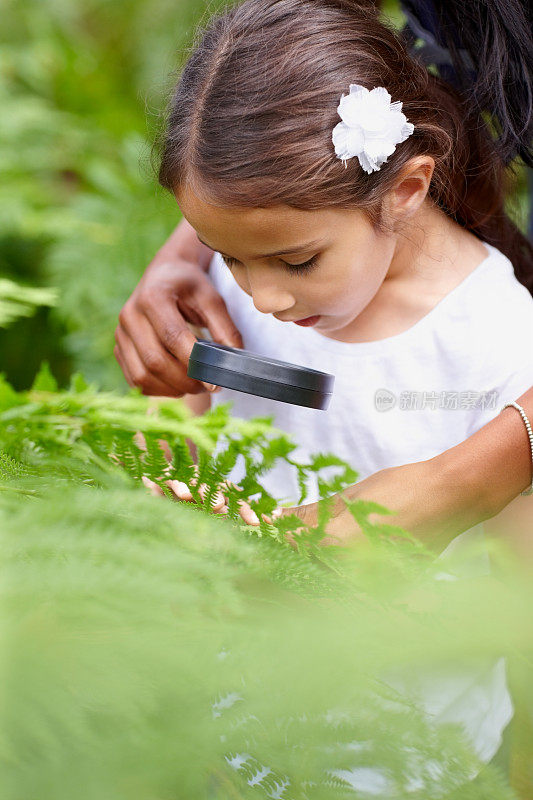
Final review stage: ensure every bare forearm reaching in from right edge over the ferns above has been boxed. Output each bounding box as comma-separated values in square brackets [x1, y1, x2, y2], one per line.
[284, 387, 533, 557]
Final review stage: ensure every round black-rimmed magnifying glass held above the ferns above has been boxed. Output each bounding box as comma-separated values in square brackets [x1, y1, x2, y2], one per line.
[187, 339, 335, 410]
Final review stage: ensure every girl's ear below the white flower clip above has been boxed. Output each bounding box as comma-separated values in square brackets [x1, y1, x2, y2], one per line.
[384, 156, 435, 225]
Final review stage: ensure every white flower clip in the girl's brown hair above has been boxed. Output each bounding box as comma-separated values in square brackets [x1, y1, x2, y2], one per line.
[331, 83, 415, 174]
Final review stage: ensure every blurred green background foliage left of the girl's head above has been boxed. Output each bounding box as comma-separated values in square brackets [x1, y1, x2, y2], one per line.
[0, 0, 233, 388]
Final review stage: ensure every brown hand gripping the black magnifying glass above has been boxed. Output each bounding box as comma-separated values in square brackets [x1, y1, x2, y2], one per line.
[114, 256, 243, 397]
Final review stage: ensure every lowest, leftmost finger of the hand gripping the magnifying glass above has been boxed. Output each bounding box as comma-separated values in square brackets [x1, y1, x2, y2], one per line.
[119, 315, 198, 397]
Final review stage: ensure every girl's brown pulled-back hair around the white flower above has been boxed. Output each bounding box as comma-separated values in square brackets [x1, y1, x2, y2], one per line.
[159, 0, 533, 294]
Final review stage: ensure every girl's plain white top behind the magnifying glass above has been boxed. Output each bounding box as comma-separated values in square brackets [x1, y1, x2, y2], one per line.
[205, 243, 533, 788]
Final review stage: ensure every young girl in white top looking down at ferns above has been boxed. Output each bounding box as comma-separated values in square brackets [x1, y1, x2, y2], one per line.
[118, 0, 533, 788]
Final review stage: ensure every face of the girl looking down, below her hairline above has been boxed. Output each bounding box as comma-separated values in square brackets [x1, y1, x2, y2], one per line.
[176, 188, 396, 334]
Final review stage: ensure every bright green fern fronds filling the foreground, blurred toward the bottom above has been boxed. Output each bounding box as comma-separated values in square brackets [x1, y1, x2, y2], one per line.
[0, 367, 533, 800]
